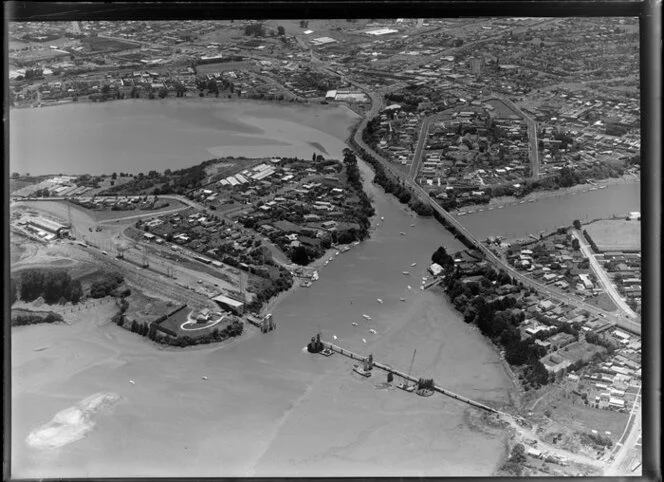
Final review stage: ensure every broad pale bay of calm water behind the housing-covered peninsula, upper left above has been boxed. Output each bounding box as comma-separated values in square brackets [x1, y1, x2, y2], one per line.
[10, 97, 361, 176]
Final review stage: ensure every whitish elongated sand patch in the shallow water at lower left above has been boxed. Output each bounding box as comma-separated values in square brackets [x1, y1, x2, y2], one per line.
[25, 392, 120, 449]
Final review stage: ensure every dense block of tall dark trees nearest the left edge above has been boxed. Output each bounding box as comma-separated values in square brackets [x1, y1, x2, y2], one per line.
[18, 270, 83, 304]
